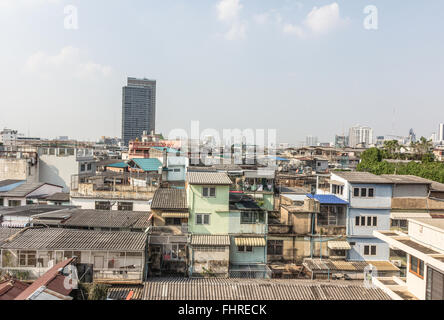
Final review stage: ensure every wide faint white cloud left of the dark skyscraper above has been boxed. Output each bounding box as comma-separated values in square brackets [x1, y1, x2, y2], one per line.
[24, 46, 112, 79]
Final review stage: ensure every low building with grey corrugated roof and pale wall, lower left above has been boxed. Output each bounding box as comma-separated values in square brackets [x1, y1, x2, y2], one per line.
[0, 228, 147, 282]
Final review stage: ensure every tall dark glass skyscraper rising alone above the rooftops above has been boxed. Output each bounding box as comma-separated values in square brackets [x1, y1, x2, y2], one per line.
[122, 78, 156, 145]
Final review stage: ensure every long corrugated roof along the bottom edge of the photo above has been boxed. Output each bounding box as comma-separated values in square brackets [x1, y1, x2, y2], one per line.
[143, 278, 390, 300]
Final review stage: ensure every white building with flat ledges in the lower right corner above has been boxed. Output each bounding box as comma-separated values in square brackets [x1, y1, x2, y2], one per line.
[373, 218, 444, 300]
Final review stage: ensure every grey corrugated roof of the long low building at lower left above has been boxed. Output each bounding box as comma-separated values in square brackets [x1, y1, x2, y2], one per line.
[0, 228, 147, 251]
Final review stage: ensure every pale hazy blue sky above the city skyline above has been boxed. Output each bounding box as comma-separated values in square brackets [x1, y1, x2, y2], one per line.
[0, 0, 444, 143]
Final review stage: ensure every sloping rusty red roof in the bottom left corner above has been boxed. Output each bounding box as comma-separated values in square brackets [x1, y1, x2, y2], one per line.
[14, 258, 75, 300]
